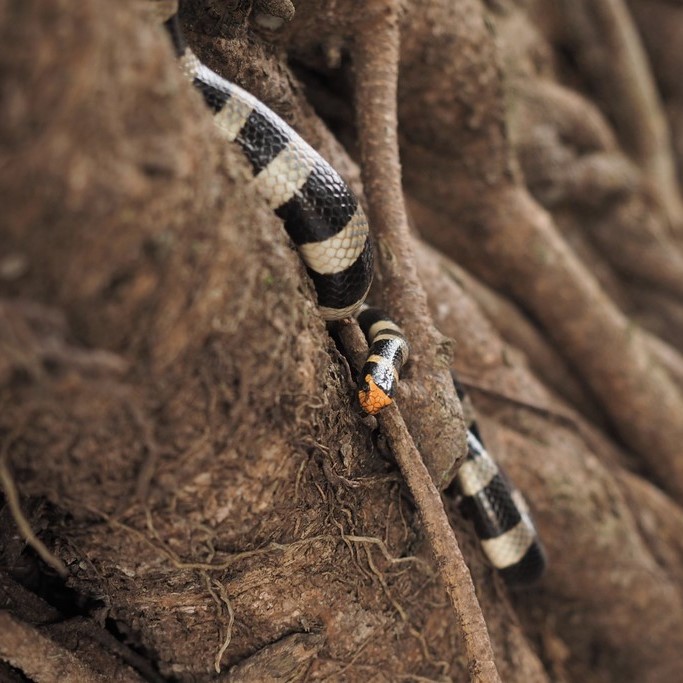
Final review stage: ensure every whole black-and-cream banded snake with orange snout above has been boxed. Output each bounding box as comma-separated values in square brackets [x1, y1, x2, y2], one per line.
[160, 10, 545, 584]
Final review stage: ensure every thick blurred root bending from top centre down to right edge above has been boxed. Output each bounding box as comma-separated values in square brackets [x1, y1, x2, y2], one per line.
[392, 2, 683, 497]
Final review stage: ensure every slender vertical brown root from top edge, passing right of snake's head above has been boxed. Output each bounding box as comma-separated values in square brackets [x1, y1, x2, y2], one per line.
[353, 0, 465, 486]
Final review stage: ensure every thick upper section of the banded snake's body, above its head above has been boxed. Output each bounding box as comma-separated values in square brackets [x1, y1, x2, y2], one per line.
[166, 15, 373, 320]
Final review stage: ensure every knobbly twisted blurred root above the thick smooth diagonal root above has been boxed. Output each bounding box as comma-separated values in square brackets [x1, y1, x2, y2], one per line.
[510, 81, 683, 304]
